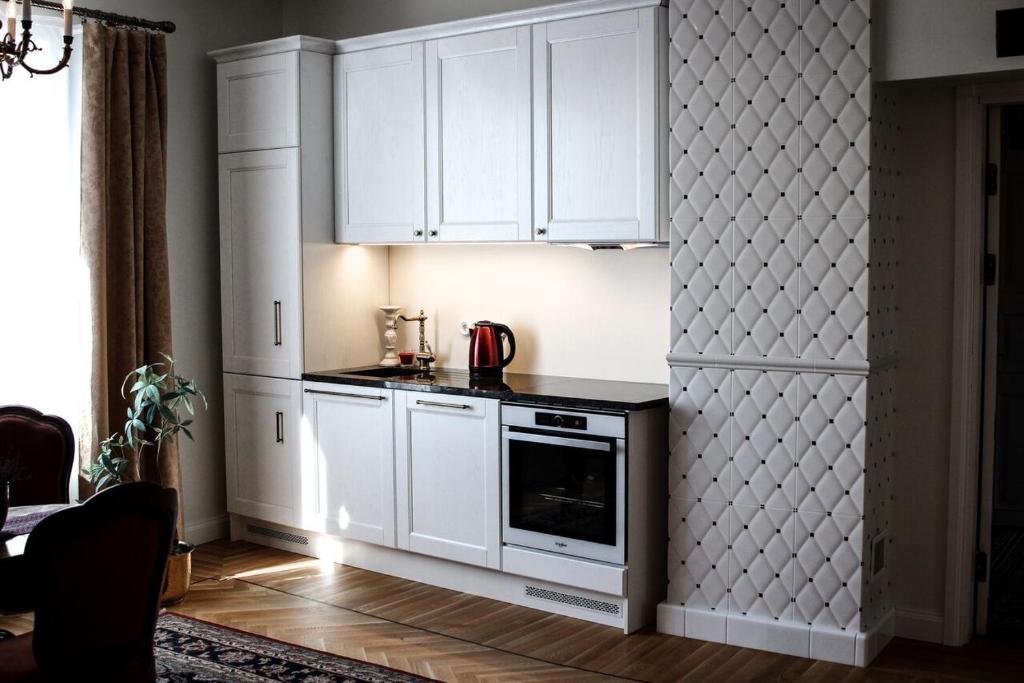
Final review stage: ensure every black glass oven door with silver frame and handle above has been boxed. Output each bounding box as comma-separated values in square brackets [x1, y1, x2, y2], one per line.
[505, 429, 623, 561]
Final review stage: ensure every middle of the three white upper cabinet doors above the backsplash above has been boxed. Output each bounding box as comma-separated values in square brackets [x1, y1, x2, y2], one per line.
[426, 27, 532, 242]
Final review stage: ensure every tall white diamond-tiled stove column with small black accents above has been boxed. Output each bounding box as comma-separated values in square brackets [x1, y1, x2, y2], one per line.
[658, 0, 899, 665]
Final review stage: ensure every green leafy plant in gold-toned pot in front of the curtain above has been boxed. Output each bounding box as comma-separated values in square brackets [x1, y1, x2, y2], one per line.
[89, 353, 207, 604]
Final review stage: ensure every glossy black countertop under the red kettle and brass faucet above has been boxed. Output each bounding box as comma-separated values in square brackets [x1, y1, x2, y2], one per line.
[302, 366, 669, 411]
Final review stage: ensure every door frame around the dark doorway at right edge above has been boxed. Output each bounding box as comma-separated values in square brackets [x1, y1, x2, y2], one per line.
[943, 82, 1024, 645]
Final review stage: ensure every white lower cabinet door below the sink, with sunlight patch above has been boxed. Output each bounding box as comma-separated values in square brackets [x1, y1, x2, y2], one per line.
[302, 383, 394, 548]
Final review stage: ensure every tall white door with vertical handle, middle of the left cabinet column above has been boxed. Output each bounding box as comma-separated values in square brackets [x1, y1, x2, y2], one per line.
[220, 148, 302, 379]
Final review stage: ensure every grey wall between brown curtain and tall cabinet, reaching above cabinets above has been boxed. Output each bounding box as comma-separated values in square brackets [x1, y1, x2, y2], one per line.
[89, 0, 282, 540]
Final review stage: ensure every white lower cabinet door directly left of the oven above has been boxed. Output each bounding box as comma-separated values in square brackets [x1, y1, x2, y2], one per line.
[395, 391, 501, 569]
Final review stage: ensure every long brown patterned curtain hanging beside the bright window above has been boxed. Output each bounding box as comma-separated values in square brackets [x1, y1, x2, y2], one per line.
[80, 23, 181, 532]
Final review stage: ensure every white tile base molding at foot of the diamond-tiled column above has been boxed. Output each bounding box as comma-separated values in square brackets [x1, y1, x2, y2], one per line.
[657, 602, 895, 667]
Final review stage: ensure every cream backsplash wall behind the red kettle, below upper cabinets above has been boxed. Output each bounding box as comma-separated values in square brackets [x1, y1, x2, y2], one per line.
[382, 245, 669, 383]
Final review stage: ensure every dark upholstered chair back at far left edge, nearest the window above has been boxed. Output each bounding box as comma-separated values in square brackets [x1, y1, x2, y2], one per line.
[0, 405, 75, 506]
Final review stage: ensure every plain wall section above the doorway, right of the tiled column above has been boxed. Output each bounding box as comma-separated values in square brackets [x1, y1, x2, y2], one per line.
[871, 0, 1024, 81]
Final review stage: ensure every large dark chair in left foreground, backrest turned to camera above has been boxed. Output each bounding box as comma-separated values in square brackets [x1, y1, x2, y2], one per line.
[0, 483, 178, 683]
